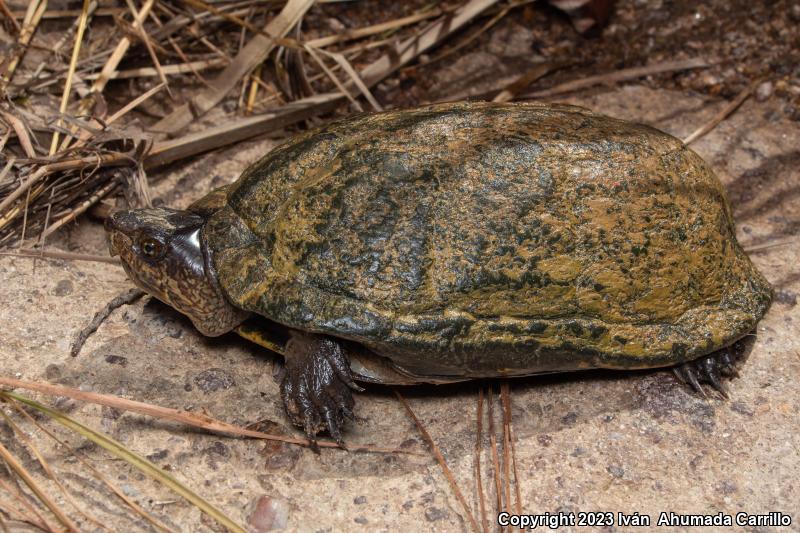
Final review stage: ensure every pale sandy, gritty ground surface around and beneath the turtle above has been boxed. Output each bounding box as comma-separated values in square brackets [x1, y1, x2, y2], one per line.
[0, 86, 800, 531]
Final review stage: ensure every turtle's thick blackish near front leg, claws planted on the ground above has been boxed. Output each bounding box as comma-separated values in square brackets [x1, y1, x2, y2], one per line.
[281, 330, 364, 448]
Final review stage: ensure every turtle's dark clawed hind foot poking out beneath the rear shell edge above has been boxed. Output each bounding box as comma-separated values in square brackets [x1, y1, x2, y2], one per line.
[672, 338, 752, 399]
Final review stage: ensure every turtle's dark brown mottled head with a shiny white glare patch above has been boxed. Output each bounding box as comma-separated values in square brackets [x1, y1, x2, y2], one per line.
[106, 207, 247, 337]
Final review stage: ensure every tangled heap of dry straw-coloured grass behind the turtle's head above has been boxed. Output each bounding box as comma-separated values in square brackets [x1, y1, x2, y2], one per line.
[0, 0, 506, 249]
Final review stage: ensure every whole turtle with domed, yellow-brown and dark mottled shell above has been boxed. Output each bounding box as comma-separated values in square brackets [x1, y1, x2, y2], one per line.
[106, 102, 772, 444]
